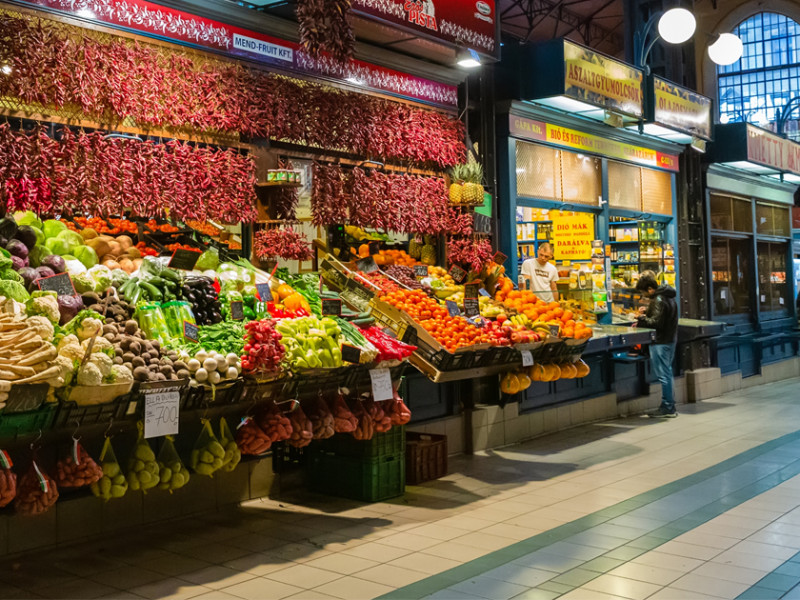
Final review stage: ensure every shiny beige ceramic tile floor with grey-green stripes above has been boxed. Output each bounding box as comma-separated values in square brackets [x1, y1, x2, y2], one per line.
[0, 380, 800, 600]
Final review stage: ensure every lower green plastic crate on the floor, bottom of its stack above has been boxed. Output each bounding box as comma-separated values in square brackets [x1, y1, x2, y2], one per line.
[308, 452, 406, 502]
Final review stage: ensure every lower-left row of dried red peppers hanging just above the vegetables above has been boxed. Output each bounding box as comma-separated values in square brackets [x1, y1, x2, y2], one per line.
[0, 123, 256, 223]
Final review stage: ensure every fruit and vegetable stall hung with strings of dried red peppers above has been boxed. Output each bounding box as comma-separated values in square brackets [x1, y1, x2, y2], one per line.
[0, 0, 516, 554]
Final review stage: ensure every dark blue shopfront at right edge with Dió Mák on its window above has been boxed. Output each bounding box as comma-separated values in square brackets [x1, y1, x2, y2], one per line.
[706, 123, 800, 376]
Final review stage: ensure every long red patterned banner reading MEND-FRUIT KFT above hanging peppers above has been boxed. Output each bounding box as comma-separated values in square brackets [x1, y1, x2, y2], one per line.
[14, 0, 458, 108]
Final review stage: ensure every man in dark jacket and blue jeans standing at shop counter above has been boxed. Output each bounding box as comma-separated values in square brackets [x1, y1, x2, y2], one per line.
[636, 271, 678, 419]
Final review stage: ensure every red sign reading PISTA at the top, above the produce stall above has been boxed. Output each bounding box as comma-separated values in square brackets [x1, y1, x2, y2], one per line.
[353, 0, 500, 58]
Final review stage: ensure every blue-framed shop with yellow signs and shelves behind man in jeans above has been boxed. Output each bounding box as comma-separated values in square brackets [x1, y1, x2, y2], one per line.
[498, 40, 691, 409]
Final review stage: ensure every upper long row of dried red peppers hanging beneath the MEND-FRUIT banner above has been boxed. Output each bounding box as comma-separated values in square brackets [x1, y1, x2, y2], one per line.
[0, 12, 466, 166]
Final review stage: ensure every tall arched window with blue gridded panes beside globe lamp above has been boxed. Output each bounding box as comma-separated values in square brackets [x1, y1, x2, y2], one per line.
[717, 12, 800, 139]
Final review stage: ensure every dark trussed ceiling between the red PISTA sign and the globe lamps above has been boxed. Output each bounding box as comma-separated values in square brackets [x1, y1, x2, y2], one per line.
[497, 0, 624, 56]
